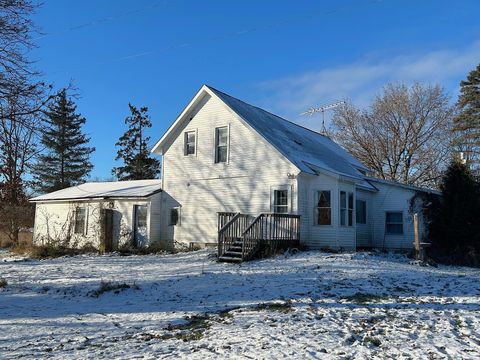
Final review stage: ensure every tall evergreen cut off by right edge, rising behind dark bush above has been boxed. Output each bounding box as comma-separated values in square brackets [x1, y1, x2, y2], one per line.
[454, 64, 480, 166]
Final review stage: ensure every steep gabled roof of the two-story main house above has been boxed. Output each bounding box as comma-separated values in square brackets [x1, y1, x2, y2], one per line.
[152, 85, 369, 179]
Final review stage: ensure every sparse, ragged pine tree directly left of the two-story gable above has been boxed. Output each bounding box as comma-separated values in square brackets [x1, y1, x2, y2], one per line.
[112, 103, 160, 180]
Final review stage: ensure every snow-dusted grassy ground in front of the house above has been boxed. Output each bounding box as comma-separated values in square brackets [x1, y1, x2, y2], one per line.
[0, 250, 480, 359]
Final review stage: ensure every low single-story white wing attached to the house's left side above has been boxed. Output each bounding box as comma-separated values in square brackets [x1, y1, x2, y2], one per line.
[30, 180, 162, 251]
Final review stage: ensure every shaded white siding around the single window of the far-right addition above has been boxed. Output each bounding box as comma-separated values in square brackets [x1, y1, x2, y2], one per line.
[371, 182, 423, 250]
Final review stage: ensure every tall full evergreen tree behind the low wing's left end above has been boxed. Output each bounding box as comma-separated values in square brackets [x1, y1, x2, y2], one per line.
[34, 90, 95, 193]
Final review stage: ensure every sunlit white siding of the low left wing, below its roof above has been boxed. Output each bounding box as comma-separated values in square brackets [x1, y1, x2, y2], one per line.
[34, 194, 160, 248]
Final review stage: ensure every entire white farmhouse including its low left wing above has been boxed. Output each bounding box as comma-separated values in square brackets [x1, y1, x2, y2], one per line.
[32, 85, 432, 260]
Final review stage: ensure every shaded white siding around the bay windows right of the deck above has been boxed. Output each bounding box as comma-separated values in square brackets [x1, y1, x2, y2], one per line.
[298, 174, 355, 250]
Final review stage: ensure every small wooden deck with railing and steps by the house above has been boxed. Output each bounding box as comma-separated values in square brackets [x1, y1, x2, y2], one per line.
[218, 212, 300, 262]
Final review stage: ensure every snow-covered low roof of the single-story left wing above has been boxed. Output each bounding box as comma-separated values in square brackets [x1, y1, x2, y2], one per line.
[30, 180, 162, 201]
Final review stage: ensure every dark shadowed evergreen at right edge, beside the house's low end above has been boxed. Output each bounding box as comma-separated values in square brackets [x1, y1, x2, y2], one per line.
[429, 160, 480, 265]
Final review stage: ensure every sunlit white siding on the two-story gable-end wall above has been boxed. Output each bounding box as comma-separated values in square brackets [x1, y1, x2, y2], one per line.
[162, 98, 298, 248]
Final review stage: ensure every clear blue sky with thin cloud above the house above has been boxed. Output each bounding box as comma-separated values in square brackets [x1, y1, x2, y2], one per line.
[32, 0, 480, 178]
